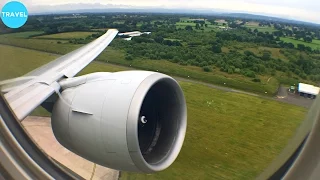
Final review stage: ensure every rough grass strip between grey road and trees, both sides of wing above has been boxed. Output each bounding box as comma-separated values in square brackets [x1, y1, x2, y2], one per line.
[0, 32, 278, 95]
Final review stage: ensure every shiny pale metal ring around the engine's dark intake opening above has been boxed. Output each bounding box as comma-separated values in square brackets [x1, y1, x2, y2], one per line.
[126, 73, 187, 173]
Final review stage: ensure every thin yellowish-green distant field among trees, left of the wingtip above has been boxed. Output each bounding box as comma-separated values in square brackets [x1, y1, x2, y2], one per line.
[35, 32, 93, 40]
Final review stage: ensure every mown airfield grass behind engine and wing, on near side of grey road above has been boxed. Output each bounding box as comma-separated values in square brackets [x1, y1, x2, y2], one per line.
[0, 46, 306, 180]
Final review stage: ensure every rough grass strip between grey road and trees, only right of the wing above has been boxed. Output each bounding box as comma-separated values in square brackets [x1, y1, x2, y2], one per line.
[98, 48, 278, 95]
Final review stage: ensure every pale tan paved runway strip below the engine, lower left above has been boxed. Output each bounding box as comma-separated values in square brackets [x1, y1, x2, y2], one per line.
[22, 117, 119, 180]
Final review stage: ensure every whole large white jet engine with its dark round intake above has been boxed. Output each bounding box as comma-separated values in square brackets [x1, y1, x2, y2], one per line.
[52, 71, 187, 173]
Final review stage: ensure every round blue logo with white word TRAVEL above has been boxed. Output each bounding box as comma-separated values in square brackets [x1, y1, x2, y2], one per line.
[1, 1, 28, 28]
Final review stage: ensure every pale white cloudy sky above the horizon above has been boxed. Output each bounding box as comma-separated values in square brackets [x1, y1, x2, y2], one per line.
[0, 0, 320, 24]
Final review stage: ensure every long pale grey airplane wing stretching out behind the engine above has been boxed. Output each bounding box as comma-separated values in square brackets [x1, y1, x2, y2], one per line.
[1, 29, 118, 120]
